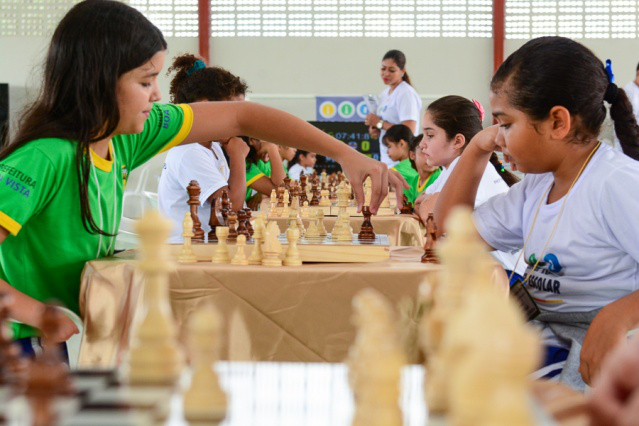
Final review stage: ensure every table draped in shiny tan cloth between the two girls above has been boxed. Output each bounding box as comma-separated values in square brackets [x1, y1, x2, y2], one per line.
[78, 247, 439, 368]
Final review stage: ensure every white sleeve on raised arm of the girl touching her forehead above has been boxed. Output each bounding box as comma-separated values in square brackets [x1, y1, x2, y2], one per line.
[473, 178, 527, 252]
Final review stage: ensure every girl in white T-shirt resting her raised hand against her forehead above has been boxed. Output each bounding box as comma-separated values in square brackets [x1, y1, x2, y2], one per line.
[435, 37, 639, 389]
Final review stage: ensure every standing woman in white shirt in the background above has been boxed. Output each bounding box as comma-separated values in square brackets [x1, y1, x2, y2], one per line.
[365, 50, 422, 167]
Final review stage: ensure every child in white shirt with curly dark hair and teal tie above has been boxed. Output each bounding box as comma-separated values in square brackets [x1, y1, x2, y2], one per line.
[158, 54, 249, 243]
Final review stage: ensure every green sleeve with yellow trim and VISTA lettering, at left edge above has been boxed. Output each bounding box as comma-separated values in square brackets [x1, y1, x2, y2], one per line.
[0, 146, 59, 236]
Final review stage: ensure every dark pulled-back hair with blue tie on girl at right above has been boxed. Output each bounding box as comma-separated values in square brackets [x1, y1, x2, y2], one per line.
[490, 37, 639, 160]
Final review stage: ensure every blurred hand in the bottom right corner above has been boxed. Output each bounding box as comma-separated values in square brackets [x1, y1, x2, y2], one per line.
[589, 336, 639, 426]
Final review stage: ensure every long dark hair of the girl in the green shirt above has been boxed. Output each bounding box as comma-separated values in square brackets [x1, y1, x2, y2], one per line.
[0, 0, 167, 236]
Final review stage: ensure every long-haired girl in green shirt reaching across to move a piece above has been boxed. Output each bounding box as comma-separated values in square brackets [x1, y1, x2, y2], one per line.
[0, 0, 390, 356]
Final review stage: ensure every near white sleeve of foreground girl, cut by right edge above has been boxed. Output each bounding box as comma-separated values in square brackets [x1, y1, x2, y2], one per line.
[596, 167, 639, 263]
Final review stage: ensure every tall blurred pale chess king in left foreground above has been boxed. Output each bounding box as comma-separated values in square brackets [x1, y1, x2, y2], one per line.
[128, 211, 184, 385]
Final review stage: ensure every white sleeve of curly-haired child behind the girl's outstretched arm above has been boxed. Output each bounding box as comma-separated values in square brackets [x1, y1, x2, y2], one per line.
[177, 149, 228, 205]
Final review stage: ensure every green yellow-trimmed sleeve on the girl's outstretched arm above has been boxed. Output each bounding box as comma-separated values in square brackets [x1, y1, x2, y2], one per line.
[113, 104, 193, 171]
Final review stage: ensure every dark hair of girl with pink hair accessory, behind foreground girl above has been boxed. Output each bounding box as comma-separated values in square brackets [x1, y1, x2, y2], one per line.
[426, 95, 519, 186]
